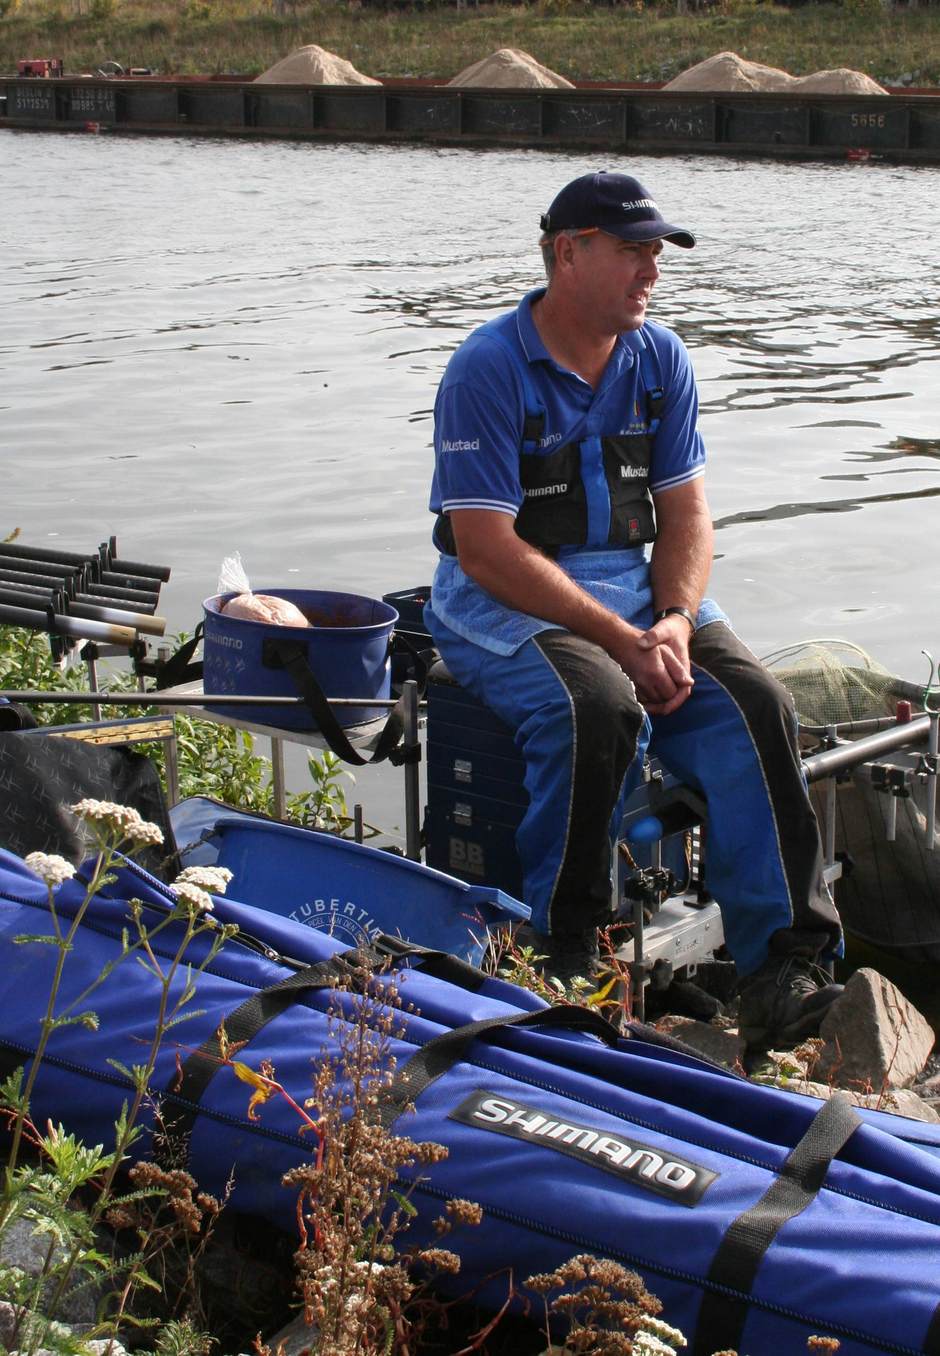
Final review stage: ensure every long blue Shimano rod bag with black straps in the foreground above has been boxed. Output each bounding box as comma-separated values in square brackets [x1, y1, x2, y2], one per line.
[0, 852, 940, 1356]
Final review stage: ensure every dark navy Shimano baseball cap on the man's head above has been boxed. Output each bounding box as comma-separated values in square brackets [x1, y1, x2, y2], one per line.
[541, 170, 696, 250]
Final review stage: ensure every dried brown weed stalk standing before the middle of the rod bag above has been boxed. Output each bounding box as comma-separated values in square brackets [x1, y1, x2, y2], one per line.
[239, 955, 482, 1356]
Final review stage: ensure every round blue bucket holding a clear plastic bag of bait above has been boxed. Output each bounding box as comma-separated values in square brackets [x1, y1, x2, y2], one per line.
[202, 589, 399, 730]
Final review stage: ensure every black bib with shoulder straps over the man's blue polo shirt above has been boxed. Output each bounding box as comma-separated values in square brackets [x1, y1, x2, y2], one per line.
[434, 330, 666, 555]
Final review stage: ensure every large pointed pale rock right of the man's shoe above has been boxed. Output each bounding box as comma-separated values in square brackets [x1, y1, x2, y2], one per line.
[812, 970, 935, 1093]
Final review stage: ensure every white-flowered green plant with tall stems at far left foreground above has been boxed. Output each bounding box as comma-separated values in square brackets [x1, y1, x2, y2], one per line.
[0, 800, 237, 1356]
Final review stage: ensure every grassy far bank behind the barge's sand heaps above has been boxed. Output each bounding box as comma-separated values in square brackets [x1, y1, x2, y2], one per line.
[0, 0, 940, 85]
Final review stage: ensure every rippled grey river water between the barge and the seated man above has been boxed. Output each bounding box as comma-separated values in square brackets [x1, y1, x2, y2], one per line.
[0, 132, 940, 824]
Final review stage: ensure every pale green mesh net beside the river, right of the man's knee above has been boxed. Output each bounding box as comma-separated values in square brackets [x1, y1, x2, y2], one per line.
[761, 640, 924, 727]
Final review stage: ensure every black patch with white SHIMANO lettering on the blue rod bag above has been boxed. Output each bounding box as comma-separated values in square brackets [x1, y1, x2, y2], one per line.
[449, 1090, 718, 1205]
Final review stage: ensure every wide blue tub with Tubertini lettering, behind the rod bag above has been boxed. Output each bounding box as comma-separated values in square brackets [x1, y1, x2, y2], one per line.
[170, 796, 529, 965]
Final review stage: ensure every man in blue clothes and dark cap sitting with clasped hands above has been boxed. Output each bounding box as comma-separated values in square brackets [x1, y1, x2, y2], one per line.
[426, 172, 841, 1044]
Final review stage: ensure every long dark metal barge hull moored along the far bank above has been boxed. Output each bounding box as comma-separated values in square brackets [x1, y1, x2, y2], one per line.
[0, 76, 940, 164]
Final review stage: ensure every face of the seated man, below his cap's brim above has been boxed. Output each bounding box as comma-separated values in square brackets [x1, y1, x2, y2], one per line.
[574, 231, 663, 335]
